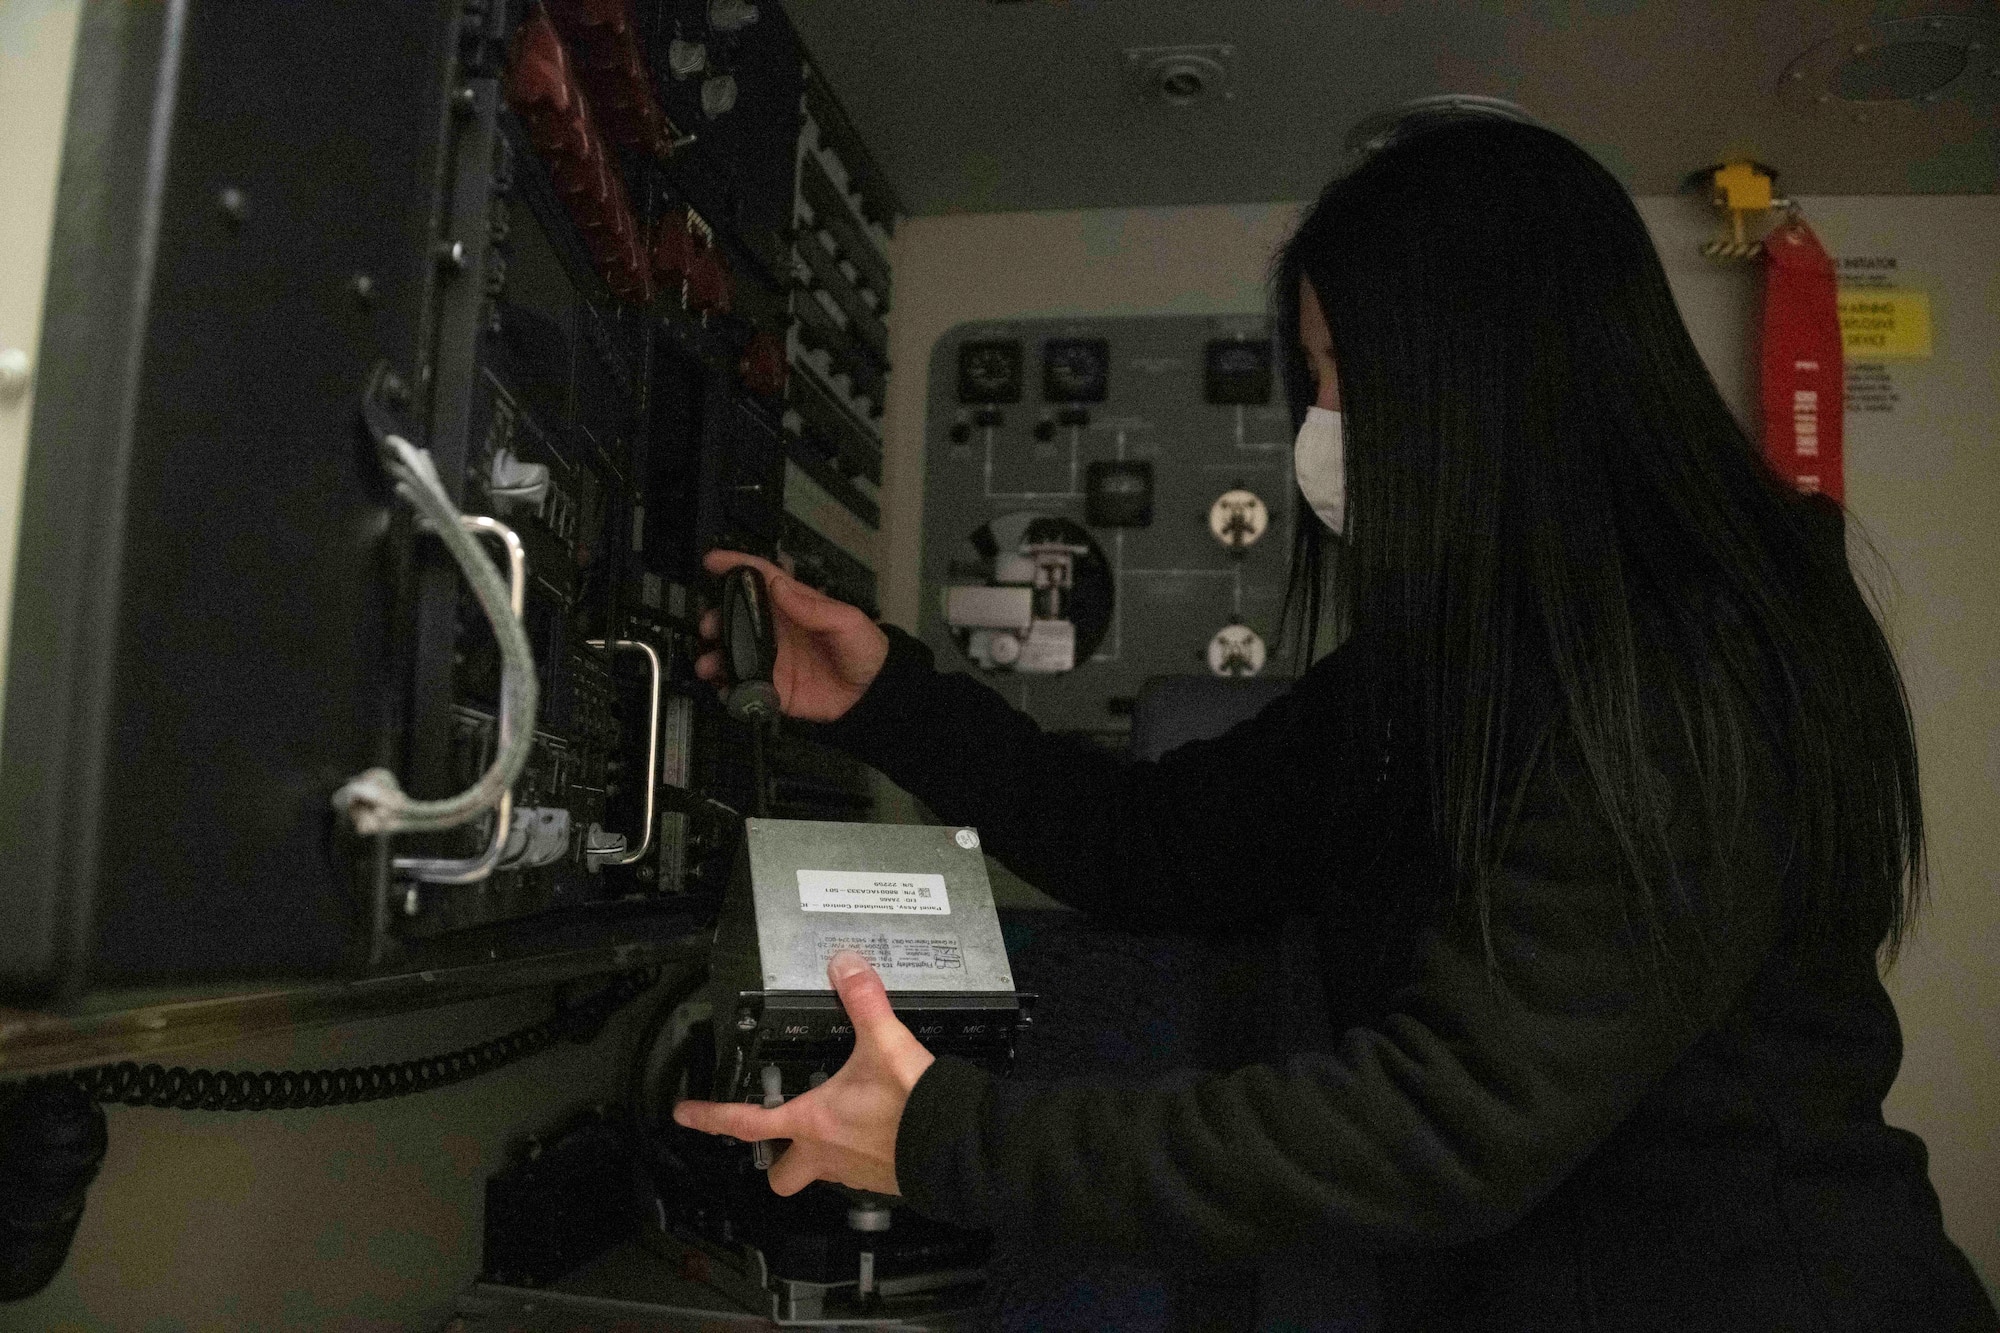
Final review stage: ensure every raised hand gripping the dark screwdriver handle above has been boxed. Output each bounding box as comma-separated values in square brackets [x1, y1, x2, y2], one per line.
[694, 550, 888, 723]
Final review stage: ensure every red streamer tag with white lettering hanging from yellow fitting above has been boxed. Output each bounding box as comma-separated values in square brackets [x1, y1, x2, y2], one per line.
[1764, 218, 1846, 504]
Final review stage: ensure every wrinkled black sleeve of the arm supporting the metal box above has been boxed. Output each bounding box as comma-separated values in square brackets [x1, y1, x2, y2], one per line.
[896, 736, 1780, 1265]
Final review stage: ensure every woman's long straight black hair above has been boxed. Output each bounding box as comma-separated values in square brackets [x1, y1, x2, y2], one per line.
[1272, 120, 1924, 953]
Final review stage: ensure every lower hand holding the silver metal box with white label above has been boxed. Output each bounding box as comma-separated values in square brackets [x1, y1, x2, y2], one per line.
[674, 949, 936, 1195]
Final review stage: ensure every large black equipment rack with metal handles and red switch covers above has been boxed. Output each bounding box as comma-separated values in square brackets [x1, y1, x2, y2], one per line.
[0, 0, 898, 999]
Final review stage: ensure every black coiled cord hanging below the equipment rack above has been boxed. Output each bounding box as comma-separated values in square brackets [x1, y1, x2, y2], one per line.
[9, 967, 660, 1111]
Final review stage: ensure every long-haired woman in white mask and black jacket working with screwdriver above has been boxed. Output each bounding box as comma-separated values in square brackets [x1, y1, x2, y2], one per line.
[676, 122, 2000, 1333]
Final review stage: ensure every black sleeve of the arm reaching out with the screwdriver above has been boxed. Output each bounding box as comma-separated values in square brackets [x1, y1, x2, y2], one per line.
[816, 626, 1382, 931]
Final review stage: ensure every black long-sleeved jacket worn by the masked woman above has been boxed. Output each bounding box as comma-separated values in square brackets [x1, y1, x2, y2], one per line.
[822, 630, 2000, 1333]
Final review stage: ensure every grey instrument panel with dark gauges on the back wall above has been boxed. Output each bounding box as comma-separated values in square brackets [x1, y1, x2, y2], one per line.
[920, 316, 1296, 743]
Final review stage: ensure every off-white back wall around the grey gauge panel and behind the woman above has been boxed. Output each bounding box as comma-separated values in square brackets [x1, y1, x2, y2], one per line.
[882, 196, 2000, 1291]
